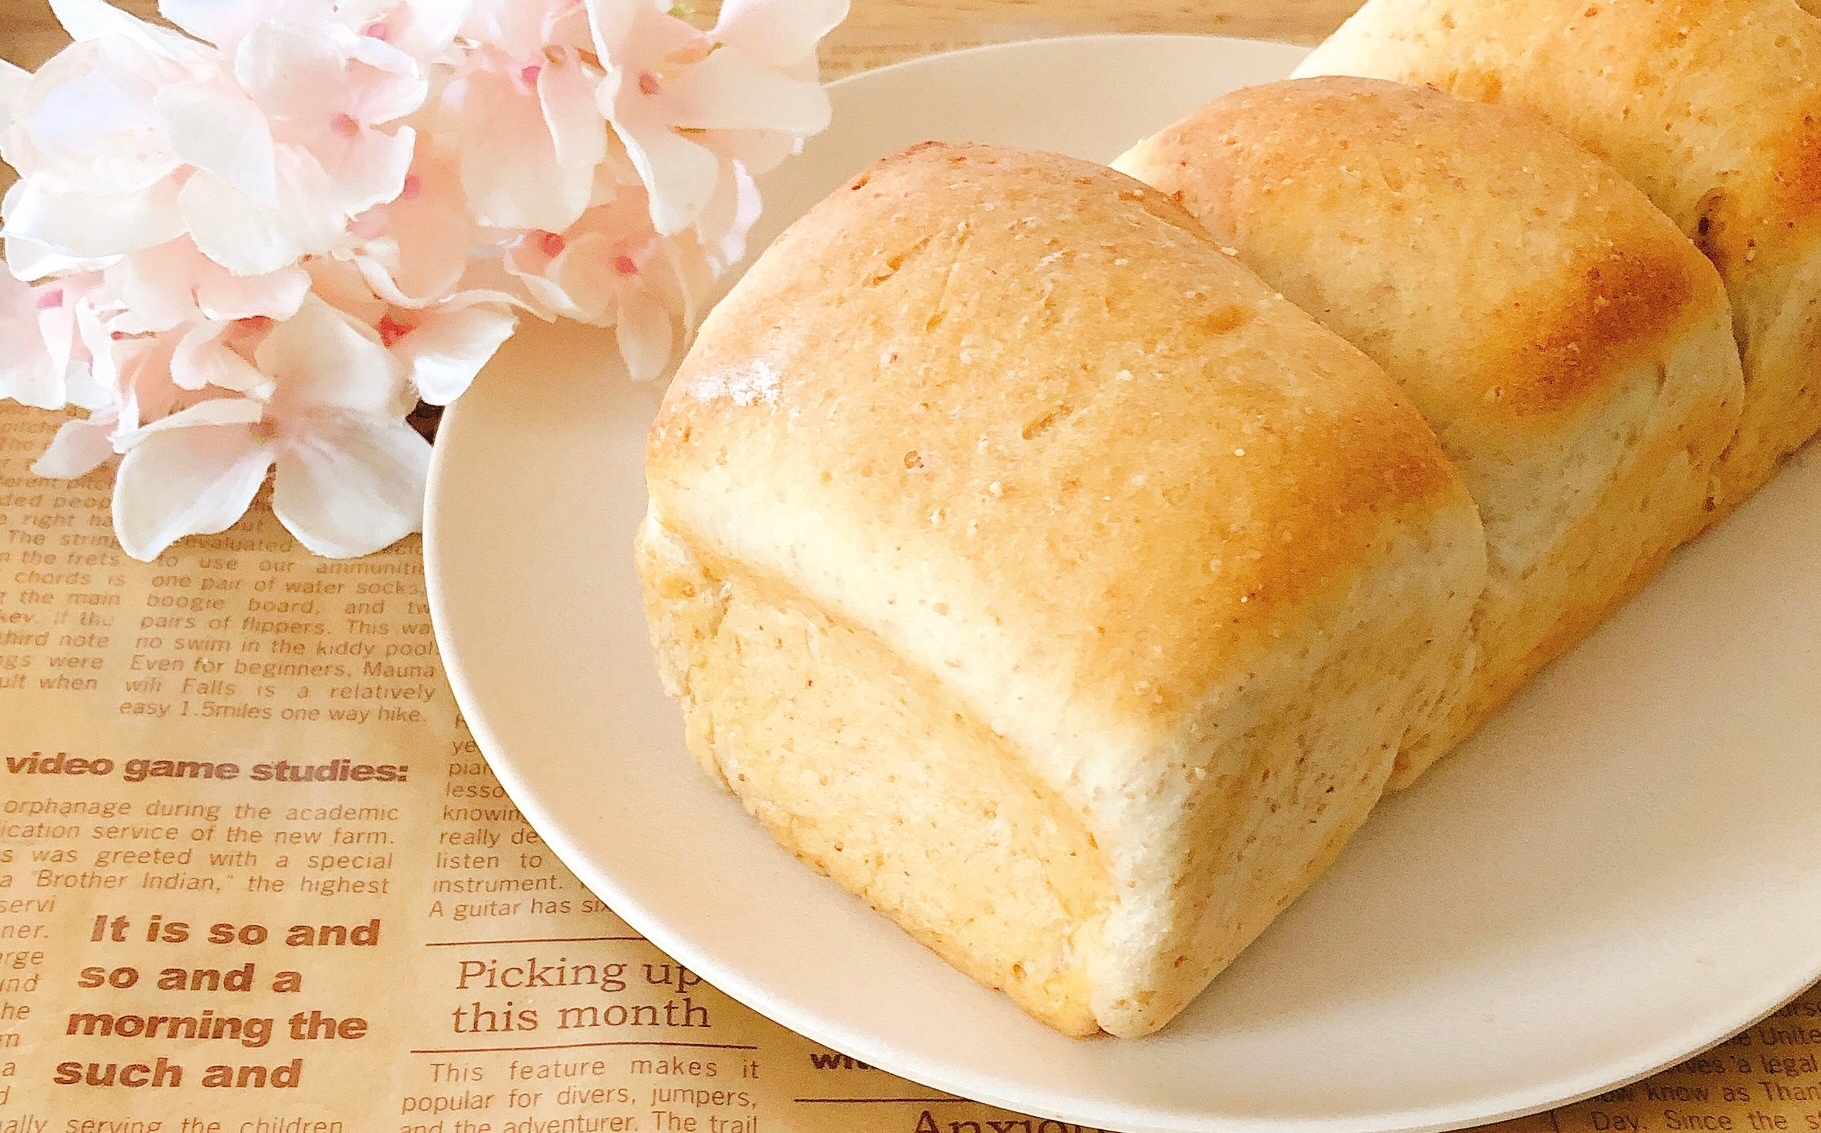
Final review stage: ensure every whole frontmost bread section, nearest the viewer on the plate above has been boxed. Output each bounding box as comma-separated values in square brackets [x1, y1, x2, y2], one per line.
[637, 144, 1485, 1035]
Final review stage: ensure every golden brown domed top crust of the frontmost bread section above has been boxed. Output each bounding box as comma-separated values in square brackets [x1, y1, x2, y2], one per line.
[648, 144, 1457, 729]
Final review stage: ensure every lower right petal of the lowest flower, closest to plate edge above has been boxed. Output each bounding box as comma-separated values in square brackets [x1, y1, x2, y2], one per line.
[271, 421, 430, 559]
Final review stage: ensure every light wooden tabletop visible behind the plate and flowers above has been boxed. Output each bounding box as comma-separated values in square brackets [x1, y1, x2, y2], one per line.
[0, 0, 1358, 78]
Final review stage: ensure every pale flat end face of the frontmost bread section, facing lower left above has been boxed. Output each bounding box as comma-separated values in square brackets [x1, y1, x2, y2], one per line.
[639, 521, 1111, 1035]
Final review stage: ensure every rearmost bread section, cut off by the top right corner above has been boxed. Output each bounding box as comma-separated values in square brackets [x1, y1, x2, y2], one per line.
[1297, 0, 1821, 515]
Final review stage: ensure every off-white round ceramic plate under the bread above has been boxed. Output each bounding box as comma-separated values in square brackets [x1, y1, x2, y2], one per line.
[426, 36, 1821, 1133]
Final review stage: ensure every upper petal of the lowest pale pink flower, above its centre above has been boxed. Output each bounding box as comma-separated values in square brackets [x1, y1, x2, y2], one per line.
[253, 295, 404, 419]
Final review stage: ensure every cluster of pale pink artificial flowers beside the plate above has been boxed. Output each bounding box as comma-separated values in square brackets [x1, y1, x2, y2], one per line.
[0, 0, 845, 559]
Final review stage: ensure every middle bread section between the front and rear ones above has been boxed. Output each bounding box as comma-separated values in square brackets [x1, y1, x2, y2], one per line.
[1114, 78, 1743, 787]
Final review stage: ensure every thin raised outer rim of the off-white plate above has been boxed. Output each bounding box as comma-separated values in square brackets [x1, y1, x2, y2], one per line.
[422, 33, 1821, 1133]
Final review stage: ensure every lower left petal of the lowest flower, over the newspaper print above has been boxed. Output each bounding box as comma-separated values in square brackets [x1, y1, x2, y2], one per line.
[113, 424, 273, 563]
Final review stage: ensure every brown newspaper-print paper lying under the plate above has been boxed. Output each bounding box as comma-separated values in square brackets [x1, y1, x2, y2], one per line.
[10, 404, 1821, 1133]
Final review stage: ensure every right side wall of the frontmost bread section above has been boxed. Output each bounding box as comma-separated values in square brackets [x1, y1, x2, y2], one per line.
[1093, 497, 1486, 1036]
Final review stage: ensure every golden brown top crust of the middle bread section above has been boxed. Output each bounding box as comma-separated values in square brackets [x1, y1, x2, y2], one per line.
[1118, 78, 1724, 428]
